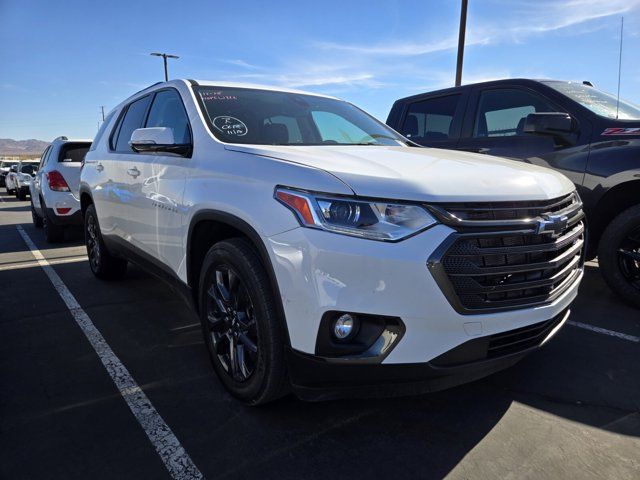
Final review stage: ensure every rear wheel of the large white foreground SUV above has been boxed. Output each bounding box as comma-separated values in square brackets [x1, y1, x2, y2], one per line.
[84, 205, 127, 280]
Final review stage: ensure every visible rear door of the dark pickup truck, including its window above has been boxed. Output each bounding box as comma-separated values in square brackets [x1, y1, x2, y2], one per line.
[397, 90, 467, 149]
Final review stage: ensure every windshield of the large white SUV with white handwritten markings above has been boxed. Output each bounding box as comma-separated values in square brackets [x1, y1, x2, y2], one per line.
[195, 86, 406, 146]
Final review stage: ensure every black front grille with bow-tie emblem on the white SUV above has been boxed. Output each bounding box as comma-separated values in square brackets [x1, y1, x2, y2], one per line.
[429, 194, 586, 313]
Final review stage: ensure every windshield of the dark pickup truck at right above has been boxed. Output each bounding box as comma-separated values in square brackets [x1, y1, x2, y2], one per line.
[543, 81, 640, 120]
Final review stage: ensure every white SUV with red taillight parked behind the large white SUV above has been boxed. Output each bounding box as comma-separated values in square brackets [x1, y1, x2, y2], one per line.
[30, 137, 91, 242]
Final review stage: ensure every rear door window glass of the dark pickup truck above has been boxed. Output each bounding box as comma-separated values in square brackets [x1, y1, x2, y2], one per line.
[400, 94, 460, 142]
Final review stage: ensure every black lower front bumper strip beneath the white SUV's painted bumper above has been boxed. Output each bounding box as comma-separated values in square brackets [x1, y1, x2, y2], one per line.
[288, 310, 570, 401]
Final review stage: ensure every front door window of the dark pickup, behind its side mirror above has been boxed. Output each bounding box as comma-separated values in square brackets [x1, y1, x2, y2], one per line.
[473, 88, 556, 137]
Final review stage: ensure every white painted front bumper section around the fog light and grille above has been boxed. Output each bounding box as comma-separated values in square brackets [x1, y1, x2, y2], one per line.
[267, 225, 582, 365]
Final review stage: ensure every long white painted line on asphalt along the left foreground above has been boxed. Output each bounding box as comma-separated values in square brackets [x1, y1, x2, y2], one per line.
[16, 225, 203, 480]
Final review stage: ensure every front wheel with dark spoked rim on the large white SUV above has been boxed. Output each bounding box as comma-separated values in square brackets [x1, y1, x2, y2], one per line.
[199, 238, 288, 405]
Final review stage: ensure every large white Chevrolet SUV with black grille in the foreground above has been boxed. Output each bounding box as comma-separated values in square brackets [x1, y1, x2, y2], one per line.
[80, 80, 585, 404]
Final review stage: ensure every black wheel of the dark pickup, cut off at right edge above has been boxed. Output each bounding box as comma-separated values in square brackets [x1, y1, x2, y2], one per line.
[598, 205, 640, 308]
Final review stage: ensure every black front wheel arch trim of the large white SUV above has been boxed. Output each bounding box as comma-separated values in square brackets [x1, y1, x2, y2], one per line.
[186, 210, 290, 345]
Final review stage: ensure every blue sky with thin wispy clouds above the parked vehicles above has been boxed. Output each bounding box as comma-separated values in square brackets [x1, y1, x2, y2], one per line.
[0, 0, 640, 140]
